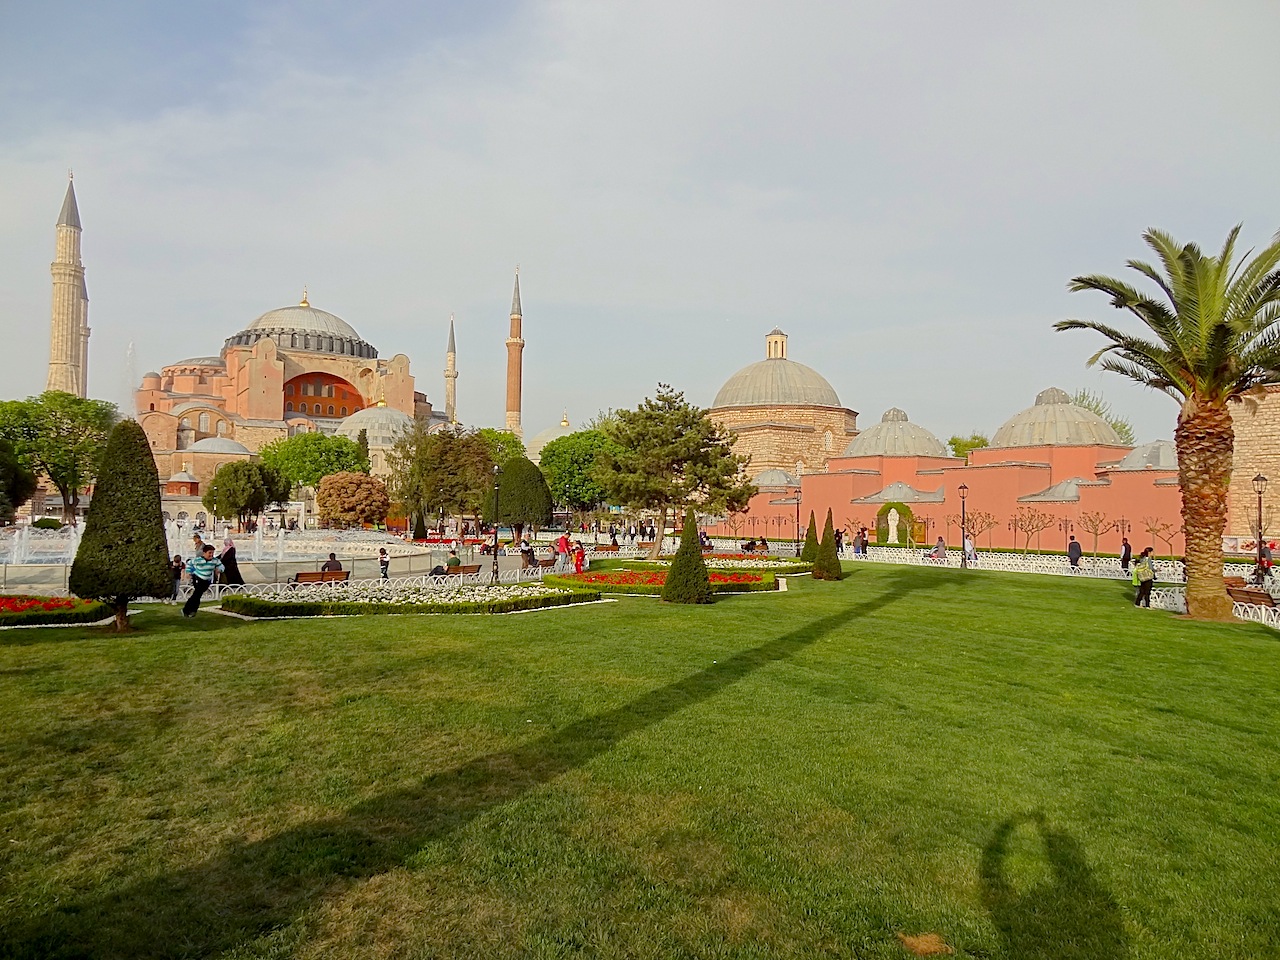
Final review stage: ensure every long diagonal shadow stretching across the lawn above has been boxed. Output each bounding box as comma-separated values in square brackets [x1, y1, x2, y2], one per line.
[0, 571, 929, 960]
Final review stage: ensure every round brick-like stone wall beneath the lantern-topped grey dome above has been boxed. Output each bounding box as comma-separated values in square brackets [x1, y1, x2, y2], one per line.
[710, 406, 858, 476]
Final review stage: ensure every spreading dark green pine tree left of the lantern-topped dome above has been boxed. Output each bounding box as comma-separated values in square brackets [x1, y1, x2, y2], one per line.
[595, 383, 755, 557]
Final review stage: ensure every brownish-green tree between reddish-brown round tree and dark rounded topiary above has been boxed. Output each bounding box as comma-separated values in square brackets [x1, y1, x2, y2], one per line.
[387, 424, 494, 536]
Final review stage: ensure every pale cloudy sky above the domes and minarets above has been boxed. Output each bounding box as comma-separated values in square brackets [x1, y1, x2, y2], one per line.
[0, 0, 1280, 440]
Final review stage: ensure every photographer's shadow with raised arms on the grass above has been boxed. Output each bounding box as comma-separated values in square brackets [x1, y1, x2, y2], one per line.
[980, 812, 1129, 960]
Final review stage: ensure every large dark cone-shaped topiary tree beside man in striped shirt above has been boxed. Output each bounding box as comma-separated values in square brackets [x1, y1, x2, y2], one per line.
[68, 420, 173, 632]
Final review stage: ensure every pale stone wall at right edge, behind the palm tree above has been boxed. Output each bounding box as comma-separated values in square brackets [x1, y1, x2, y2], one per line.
[1226, 387, 1280, 536]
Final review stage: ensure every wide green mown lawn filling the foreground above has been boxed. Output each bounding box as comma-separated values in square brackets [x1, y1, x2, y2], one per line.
[0, 564, 1280, 960]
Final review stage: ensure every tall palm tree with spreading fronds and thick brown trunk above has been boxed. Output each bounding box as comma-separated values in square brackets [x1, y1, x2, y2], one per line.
[1053, 225, 1280, 620]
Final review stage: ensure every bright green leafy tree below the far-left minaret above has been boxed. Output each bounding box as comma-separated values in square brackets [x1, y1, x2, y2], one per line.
[0, 390, 116, 524]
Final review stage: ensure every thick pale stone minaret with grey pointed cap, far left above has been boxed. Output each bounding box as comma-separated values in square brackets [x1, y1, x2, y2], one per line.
[45, 178, 88, 397]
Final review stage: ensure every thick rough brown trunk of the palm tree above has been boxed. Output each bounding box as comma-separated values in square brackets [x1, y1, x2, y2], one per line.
[1174, 399, 1235, 621]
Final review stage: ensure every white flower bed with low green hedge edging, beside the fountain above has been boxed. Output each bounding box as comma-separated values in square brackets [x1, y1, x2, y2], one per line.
[221, 581, 600, 617]
